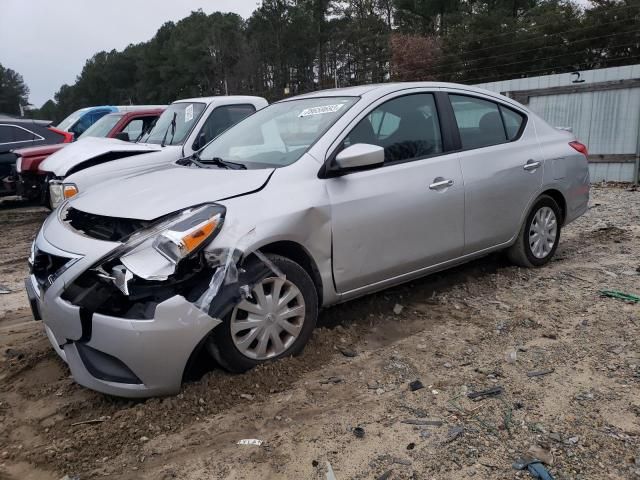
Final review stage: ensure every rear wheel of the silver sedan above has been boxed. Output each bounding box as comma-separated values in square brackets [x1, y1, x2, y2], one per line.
[507, 195, 562, 268]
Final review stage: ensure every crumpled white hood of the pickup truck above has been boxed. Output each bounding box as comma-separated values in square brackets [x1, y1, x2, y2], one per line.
[40, 137, 162, 177]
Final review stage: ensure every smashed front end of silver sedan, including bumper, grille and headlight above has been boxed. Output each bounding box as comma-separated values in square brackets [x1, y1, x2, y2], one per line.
[35, 202, 274, 397]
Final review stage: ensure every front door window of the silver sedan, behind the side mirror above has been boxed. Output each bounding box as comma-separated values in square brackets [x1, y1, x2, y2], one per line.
[343, 93, 442, 163]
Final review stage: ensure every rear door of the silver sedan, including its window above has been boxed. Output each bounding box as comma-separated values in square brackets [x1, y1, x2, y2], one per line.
[442, 92, 544, 254]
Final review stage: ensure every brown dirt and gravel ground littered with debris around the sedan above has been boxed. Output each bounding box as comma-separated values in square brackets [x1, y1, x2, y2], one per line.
[0, 186, 640, 480]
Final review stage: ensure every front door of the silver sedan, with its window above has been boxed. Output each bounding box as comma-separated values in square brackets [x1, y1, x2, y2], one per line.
[326, 91, 464, 293]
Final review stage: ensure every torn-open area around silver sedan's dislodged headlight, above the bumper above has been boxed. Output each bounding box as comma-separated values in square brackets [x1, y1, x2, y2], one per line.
[61, 204, 245, 319]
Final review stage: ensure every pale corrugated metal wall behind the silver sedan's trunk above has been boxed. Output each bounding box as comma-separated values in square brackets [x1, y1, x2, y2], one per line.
[477, 65, 640, 182]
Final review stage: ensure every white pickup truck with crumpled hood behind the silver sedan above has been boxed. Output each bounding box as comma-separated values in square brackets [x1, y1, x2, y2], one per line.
[47, 96, 268, 209]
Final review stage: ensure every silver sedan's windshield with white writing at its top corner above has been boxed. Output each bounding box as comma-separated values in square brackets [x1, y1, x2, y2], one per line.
[200, 97, 357, 168]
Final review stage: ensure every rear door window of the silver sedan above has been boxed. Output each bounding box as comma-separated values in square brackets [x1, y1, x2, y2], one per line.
[449, 95, 507, 150]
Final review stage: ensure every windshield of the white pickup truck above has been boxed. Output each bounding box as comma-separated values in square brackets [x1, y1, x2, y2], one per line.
[144, 102, 206, 145]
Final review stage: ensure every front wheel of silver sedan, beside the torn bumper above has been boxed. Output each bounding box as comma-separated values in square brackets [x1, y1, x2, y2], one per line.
[206, 254, 318, 373]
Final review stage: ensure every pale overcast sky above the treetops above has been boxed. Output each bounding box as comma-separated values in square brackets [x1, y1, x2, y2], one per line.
[0, 0, 258, 107]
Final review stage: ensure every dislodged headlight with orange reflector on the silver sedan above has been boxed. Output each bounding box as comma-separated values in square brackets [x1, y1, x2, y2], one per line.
[98, 204, 226, 284]
